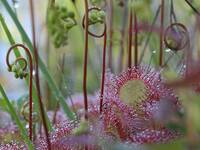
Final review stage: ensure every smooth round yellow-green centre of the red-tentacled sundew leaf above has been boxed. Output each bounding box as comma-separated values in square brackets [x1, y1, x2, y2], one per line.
[119, 79, 148, 106]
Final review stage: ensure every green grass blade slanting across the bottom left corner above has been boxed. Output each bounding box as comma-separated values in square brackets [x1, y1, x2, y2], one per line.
[0, 84, 33, 150]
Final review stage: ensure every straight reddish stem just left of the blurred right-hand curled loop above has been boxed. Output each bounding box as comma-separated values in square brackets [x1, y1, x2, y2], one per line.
[159, 0, 165, 67]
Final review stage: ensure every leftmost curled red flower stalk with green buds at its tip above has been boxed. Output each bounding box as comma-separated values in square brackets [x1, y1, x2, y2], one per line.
[6, 44, 33, 140]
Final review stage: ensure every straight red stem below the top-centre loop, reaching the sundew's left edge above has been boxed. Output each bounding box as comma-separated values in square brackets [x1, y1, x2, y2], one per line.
[100, 26, 107, 113]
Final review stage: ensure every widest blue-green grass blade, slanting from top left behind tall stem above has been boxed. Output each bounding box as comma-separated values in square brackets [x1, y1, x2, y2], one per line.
[1, 0, 74, 119]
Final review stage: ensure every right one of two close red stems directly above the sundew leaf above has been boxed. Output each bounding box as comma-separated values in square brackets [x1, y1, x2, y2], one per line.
[134, 12, 138, 66]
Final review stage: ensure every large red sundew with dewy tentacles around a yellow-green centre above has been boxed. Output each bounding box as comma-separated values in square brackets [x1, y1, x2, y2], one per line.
[103, 67, 180, 143]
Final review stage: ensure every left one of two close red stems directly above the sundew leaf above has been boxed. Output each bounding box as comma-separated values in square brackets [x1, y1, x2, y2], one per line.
[128, 9, 133, 68]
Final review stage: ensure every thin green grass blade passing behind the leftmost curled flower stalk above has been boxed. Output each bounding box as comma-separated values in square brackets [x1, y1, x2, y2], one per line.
[0, 14, 52, 131]
